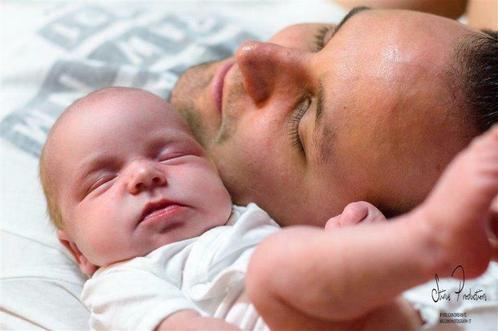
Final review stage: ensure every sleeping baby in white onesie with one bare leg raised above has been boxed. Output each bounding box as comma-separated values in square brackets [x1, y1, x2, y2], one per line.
[40, 88, 498, 330]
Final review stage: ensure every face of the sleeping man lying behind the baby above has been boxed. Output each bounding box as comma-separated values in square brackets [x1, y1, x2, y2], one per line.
[171, 10, 475, 225]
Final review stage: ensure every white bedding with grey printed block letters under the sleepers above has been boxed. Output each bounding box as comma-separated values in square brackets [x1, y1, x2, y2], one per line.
[0, 0, 498, 330]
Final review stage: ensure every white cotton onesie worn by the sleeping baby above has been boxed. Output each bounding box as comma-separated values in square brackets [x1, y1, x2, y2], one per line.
[82, 204, 279, 331]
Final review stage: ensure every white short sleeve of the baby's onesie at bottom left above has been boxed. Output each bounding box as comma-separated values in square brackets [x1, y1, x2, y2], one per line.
[82, 264, 198, 331]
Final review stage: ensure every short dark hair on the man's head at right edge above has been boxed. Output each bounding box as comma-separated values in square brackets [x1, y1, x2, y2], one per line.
[454, 30, 498, 132]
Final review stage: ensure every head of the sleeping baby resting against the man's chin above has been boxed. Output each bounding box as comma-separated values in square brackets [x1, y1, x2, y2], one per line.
[40, 87, 231, 275]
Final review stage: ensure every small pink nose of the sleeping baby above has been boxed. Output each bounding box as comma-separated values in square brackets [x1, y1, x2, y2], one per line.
[126, 160, 167, 194]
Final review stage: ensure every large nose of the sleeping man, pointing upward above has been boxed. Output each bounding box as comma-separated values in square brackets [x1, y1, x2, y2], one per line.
[235, 41, 309, 103]
